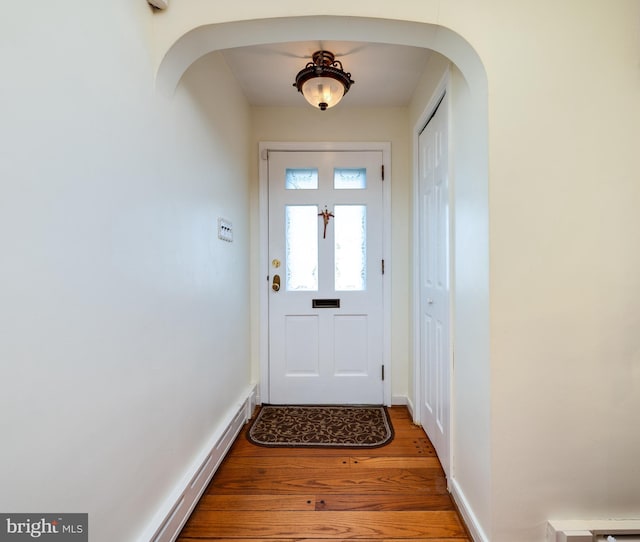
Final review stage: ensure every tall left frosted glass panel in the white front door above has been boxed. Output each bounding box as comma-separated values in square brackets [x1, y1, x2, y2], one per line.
[285, 205, 318, 291]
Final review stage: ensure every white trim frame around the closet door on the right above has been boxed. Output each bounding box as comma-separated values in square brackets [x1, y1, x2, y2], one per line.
[412, 70, 455, 460]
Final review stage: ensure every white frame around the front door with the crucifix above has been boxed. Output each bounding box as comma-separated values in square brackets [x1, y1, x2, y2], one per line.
[257, 141, 392, 406]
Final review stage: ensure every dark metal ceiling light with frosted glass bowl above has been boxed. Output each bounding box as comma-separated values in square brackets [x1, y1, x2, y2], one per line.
[293, 51, 354, 111]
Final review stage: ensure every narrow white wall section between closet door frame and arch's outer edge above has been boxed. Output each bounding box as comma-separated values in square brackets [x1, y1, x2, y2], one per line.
[450, 62, 493, 535]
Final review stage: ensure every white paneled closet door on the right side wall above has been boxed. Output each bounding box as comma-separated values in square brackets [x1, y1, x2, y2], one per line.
[418, 95, 451, 475]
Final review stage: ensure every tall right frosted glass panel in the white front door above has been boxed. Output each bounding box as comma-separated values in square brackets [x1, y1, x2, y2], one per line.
[333, 205, 367, 291]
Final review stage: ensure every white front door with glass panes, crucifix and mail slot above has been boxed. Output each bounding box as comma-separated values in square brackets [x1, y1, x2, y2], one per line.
[267, 151, 383, 404]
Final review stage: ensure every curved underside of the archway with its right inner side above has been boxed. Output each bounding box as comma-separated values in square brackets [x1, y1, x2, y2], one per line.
[156, 16, 491, 540]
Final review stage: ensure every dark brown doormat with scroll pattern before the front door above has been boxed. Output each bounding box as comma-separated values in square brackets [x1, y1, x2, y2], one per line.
[247, 405, 393, 448]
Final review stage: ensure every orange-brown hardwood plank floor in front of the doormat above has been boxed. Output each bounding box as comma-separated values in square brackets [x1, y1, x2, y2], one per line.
[178, 407, 471, 542]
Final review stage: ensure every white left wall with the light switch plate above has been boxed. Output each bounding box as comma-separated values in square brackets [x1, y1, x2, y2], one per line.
[0, 0, 250, 542]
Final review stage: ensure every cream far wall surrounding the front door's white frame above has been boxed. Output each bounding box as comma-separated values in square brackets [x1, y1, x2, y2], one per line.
[251, 107, 411, 404]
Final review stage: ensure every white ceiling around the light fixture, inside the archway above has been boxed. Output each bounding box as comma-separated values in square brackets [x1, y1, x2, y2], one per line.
[223, 41, 431, 108]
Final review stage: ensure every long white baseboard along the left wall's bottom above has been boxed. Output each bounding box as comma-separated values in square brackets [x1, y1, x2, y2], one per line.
[138, 386, 256, 542]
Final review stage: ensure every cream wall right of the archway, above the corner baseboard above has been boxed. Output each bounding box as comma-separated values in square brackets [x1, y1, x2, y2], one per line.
[482, 1, 640, 541]
